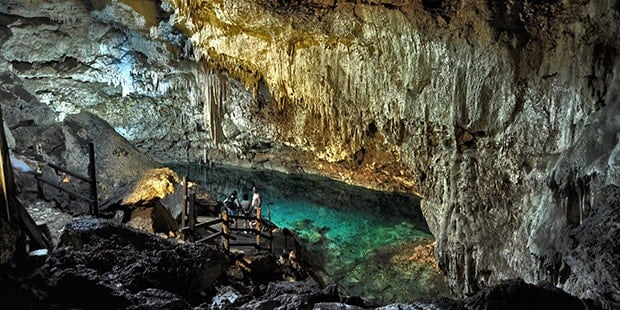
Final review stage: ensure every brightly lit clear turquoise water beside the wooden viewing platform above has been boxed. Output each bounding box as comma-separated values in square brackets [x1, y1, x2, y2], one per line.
[270, 200, 448, 305]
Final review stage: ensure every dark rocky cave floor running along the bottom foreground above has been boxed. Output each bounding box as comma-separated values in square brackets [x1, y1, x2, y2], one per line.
[0, 208, 600, 309]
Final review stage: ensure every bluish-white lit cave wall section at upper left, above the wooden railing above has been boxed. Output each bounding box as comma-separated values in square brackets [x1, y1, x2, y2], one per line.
[0, 0, 245, 161]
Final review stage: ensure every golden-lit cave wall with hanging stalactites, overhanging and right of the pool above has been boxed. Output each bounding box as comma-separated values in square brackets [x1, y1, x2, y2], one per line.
[173, 0, 620, 306]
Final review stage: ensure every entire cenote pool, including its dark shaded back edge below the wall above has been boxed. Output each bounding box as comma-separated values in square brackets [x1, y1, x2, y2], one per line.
[170, 164, 449, 304]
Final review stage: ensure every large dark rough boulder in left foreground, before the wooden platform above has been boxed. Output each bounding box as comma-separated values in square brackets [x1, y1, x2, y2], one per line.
[22, 217, 229, 309]
